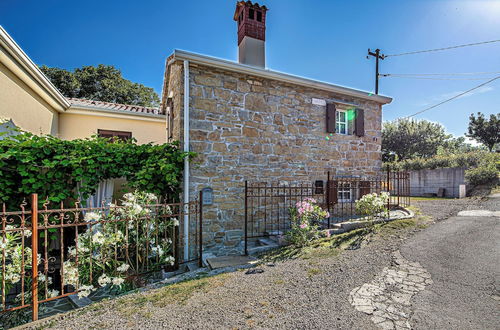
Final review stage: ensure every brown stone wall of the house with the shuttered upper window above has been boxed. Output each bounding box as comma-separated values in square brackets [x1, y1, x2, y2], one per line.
[169, 59, 382, 255]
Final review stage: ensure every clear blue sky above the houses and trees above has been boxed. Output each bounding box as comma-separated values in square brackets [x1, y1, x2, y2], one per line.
[0, 0, 500, 135]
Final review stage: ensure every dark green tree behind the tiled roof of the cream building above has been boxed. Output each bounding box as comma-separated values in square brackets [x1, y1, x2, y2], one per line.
[40, 64, 160, 107]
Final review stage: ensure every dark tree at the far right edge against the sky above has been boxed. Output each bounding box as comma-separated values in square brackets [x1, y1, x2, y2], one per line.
[466, 112, 500, 152]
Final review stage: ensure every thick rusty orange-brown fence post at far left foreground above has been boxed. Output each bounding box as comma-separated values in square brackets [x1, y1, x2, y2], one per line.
[31, 194, 38, 321]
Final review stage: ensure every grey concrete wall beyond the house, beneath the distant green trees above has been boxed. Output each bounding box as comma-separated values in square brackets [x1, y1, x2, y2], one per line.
[410, 168, 465, 198]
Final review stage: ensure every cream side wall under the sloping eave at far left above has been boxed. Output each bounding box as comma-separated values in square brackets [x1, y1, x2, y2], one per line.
[0, 63, 58, 135]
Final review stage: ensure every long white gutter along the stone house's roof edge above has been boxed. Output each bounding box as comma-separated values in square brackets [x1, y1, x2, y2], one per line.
[171, 49, 392, 104]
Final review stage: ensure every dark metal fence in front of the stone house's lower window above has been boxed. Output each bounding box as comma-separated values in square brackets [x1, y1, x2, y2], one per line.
[245, 172, 410, 249]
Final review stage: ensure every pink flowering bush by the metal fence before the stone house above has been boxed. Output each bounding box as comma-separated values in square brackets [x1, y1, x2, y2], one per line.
[286, 198, 330, 247]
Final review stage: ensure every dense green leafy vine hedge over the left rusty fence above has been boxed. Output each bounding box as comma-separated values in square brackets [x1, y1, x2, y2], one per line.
[0, 133, 194, 208]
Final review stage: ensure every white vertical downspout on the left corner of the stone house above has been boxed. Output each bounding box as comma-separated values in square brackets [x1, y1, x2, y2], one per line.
[184, 60, 189, 261]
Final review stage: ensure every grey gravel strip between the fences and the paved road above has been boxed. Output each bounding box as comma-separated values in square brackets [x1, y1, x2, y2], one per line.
[26, 199, 479, 329]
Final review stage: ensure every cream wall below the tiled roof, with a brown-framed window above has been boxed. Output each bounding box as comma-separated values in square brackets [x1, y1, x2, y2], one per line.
[59, 110, 167, 144]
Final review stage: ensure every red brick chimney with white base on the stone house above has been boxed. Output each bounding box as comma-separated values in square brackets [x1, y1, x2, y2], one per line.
[234, 1, 268, 68]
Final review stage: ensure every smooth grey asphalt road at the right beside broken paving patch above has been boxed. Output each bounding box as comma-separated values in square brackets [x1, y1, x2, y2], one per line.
[400, 196, 500, 329]
